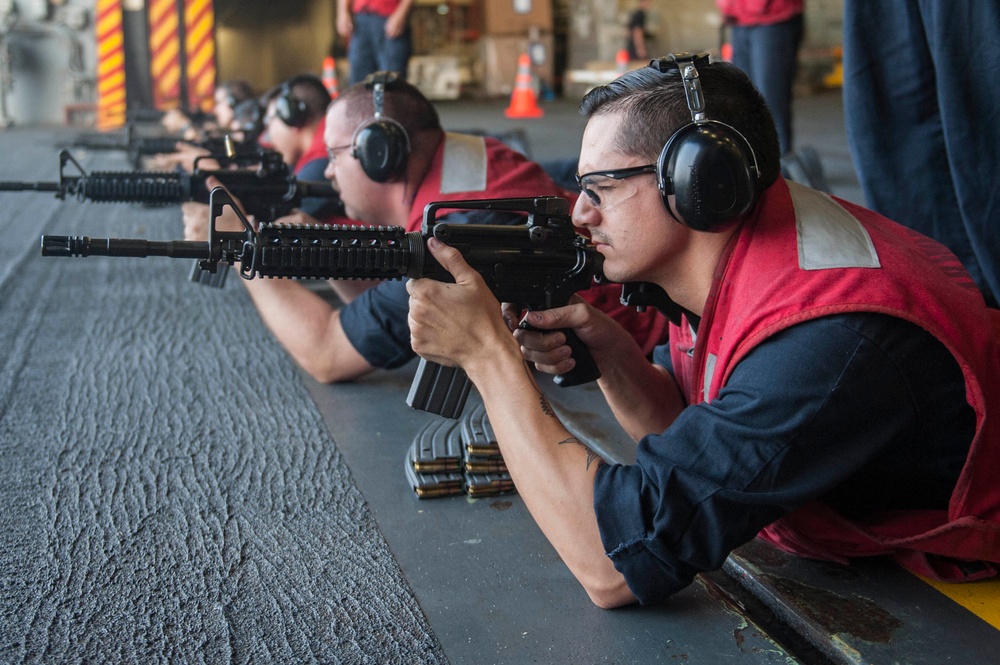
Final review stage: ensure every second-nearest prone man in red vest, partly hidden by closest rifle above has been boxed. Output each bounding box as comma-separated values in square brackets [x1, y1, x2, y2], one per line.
[184, 73, 666, 383]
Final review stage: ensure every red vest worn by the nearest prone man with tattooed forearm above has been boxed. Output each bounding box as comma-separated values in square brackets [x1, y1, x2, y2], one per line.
[671, 179, 1000, 581]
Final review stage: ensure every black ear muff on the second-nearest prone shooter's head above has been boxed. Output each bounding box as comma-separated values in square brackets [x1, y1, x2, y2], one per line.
[351, 72, 410, 182]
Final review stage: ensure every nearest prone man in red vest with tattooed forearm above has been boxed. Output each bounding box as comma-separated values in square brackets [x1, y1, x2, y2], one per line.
[408, 54, 1000, 607]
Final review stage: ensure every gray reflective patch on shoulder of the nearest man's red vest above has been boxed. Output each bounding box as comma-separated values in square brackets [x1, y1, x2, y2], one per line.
[788, 181, 881, 270]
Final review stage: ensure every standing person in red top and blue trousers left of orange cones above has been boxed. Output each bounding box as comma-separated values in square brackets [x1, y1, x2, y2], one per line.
[337, 0, 413, 84]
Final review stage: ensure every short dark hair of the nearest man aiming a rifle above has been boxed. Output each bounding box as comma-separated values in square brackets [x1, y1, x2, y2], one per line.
[580, 57, 781, 194]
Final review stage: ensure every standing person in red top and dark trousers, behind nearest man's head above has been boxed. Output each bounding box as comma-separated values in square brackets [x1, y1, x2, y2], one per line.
[716, 0, 805, 157]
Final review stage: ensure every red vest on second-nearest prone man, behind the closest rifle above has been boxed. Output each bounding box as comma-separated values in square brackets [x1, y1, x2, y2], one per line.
[406, 132, 667, 354]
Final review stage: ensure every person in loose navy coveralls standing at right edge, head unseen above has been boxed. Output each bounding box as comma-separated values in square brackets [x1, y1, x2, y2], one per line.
[844, 0, 1000, 306]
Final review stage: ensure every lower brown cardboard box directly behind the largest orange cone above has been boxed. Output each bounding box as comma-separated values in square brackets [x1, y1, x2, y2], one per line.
[478, 33, 555, 97]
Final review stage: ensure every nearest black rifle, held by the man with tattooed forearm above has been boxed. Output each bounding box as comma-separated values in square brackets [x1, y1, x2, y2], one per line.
[42, 188, 603, 418]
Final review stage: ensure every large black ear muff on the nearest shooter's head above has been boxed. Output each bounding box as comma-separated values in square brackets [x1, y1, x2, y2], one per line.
[650, 53, 760, 231]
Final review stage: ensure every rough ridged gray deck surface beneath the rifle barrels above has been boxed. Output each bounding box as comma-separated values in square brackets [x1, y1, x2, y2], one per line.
[0, 129, 445, 663]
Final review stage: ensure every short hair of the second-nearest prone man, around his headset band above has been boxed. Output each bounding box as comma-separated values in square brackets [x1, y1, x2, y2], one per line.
[334, 79, 441, 145]
